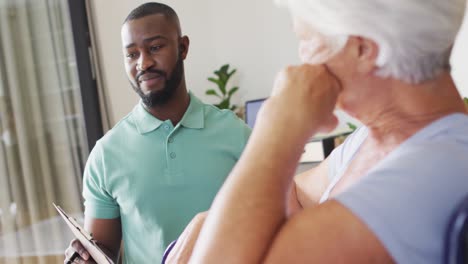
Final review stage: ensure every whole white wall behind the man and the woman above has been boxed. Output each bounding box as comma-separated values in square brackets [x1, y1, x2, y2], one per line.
[89, 0, 468, 125]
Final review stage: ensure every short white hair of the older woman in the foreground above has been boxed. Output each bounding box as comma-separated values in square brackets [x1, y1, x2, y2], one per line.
[277, 0, 466, 83]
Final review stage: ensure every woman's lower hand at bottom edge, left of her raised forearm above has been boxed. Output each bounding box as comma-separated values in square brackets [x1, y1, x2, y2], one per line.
[166, 212, 208, 264]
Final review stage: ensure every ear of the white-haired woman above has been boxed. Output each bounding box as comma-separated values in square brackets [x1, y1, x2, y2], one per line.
[355, 37, 379, 74]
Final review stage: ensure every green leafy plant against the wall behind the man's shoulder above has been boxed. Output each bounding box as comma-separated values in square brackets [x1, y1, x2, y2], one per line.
[206, 64, 239, 111]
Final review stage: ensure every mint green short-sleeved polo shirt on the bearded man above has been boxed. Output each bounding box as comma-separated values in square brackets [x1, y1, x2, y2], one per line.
[83, 93, 250, 263]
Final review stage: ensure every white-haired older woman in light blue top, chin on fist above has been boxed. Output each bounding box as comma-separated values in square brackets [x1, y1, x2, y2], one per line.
[165, 0, 468, 263]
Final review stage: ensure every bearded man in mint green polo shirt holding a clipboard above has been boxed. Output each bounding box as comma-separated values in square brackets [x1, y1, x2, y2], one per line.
[65, 3, 250, 263]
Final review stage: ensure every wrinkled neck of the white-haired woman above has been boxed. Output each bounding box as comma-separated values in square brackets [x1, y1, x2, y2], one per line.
[355, 73, 466, 145]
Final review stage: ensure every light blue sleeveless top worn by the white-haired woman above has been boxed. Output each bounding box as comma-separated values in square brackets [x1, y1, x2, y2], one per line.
[323, 114, 468, 264]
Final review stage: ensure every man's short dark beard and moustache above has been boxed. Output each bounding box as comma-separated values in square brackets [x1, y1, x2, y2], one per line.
[130, 55, 184, 108]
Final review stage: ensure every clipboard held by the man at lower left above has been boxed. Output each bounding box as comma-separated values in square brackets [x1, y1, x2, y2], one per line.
[53, 203, 114, 264]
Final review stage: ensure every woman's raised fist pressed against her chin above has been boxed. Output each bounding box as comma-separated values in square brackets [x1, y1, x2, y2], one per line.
[256, 64, 341, 141]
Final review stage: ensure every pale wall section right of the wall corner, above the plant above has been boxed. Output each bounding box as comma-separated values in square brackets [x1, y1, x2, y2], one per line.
[209, 0, 299, 102]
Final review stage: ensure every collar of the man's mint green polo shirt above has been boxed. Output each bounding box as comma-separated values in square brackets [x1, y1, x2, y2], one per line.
[133, 92, 205, 134]
